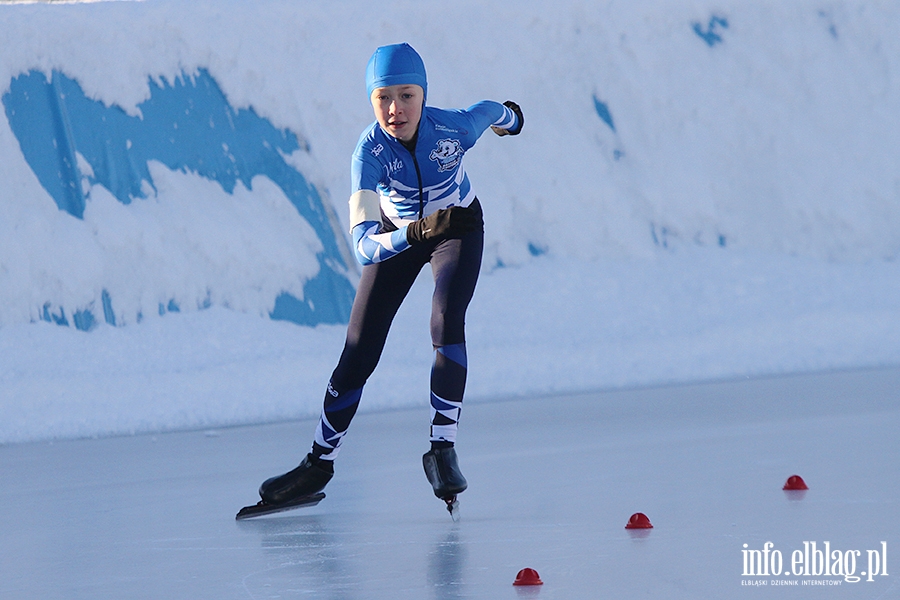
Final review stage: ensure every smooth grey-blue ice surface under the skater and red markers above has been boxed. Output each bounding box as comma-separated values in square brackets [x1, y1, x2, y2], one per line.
[0, 368, 900, 600]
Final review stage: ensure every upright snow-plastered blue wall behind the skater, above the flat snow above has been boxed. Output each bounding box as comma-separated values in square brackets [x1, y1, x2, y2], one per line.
[0, 1, 900, 329]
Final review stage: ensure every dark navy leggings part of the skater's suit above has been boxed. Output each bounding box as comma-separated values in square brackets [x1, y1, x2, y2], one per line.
[313, 200, 484, 459]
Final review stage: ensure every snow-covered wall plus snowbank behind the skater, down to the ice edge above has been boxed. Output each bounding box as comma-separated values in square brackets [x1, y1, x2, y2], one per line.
[0, 0, 900, 443]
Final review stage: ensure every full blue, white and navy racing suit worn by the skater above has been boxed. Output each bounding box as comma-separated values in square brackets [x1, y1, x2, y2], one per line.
[312, 101, 519, 460]
